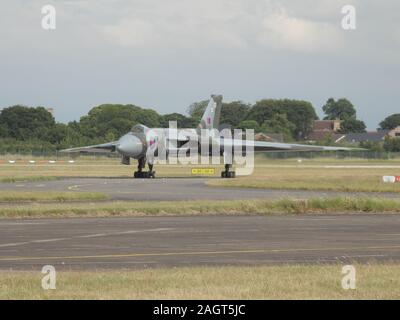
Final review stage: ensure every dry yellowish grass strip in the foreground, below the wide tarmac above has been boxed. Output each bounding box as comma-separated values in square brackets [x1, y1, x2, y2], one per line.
[0, 264, 400, 299]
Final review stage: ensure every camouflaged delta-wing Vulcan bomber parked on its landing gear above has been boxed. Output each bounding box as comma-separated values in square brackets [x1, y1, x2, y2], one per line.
[62, 95, 354, 178]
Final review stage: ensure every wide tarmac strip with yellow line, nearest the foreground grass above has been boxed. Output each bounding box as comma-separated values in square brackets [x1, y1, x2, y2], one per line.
[0, 214, 400, 271]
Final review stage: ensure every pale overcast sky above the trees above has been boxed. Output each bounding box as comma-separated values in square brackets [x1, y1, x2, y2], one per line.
[0, 0, 400, 129]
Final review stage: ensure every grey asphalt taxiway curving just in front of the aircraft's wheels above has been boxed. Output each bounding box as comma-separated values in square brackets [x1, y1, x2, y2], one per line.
[0, 178, 398, 201]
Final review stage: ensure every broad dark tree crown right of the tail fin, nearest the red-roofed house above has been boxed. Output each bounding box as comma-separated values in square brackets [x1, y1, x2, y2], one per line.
[247, 99, 318, 139]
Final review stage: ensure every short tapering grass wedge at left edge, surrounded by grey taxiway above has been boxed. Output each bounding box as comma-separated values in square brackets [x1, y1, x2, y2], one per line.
[0, 191, 108, 202]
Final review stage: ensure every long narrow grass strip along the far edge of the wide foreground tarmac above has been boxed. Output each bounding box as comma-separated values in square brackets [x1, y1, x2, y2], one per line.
[0, 197, 400, 218]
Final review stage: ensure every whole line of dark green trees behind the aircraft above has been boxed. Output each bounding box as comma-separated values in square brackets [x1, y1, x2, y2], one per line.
[0, 98, 400, 152]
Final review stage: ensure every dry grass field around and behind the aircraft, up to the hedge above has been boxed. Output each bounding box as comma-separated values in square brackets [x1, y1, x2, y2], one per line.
[0, 156, 400, 192]
